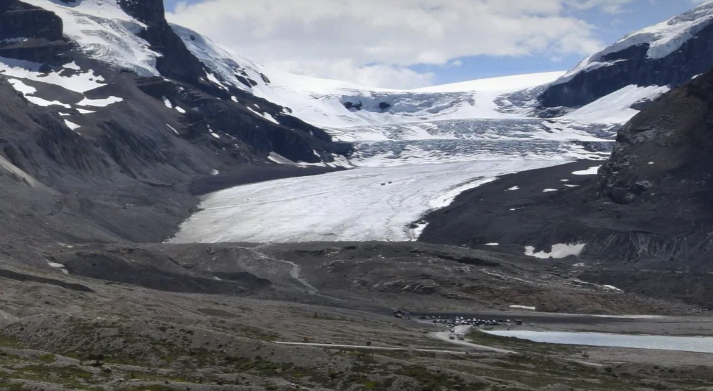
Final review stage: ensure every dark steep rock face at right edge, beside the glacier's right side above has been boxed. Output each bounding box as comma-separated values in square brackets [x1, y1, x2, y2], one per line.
[599, 68, 713, 214]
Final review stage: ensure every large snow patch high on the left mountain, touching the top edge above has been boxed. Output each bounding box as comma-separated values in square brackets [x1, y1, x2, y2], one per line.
[23, 0, 161, 76]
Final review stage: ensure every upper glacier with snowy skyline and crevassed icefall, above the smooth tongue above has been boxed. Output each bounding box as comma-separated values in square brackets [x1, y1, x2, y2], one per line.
[172, 25, 636, 166]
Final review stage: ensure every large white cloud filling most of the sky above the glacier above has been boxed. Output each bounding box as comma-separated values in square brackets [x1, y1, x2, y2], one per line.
[168, 0, 700, 88]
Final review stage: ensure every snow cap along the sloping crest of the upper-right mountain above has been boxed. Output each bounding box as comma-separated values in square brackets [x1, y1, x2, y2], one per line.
[553, 1, 713, 84]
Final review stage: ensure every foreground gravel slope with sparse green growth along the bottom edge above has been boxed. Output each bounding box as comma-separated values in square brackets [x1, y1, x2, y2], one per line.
[0, 264, 713, 391]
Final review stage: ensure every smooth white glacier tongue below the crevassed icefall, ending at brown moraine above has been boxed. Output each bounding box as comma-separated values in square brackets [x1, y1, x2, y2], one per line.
[170, 159, 566, 243]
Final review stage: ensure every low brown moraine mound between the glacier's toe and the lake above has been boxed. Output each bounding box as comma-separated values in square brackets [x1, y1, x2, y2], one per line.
[20, 242, 698, 314]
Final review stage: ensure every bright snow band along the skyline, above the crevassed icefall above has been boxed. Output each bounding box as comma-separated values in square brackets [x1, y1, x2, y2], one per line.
[171, 25, 564, 128]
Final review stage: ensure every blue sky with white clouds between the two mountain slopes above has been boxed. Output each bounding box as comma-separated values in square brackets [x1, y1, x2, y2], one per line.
[165, 0, 701, 88]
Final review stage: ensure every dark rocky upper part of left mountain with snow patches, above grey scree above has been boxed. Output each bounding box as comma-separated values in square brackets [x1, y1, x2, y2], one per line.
[0, 0, 350, 171]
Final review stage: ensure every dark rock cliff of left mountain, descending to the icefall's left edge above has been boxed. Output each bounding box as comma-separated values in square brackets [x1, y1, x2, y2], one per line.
[112, 0, 352, 163]
